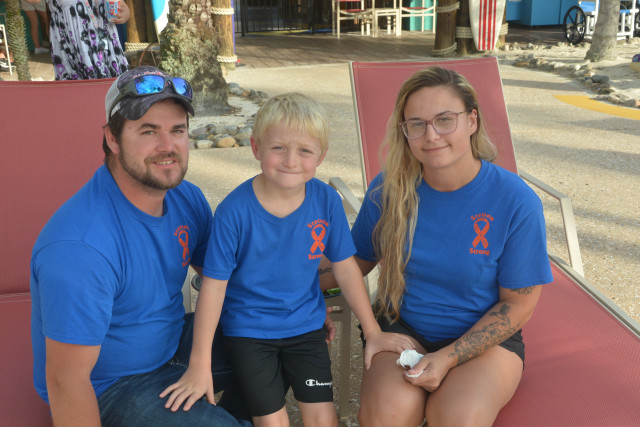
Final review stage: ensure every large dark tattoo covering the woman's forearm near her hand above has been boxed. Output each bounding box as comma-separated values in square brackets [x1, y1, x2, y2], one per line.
[449, 304, 518, 365]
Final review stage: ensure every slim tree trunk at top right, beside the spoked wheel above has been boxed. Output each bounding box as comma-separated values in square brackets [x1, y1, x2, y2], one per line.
[585, 0, 620, 62]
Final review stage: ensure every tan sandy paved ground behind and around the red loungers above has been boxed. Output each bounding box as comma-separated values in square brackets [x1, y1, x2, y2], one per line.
[187, 39, 640, 426]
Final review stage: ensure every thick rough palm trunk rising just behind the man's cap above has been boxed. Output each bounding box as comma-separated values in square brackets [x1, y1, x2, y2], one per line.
[160, 0, 231, 115]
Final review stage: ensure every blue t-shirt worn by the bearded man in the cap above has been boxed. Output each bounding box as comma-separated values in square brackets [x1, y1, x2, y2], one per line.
[31, 166, 212, 401]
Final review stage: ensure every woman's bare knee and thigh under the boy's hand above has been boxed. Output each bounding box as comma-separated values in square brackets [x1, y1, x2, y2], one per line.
[358, 352, 431, 427]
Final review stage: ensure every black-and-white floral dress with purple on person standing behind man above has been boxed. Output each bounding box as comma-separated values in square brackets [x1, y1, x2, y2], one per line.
[47, 0, 129, 80]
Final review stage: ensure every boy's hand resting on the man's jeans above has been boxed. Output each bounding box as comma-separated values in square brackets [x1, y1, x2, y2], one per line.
[160, 367, 216, 412]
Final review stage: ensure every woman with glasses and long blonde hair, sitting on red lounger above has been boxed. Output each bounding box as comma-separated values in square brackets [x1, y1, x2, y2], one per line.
[322, 67, 552, 427]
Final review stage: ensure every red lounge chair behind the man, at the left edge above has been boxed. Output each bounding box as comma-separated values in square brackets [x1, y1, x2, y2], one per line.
[0, 79, 113, 426]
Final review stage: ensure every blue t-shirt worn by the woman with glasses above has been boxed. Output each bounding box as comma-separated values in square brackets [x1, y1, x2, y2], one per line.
[352, 161, 553, 341]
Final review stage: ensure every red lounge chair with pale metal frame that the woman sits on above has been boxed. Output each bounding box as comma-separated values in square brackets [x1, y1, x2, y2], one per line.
[330, 58, 640, 427]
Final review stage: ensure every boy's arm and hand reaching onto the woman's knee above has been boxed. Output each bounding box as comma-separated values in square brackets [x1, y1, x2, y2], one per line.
[333, 257, 415, 369]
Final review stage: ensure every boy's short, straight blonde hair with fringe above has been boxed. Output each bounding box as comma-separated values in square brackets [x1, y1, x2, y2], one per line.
[252, 92, 329, 154]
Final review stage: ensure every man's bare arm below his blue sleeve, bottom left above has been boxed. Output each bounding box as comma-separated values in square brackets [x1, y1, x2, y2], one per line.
[46, 338, 100, 426]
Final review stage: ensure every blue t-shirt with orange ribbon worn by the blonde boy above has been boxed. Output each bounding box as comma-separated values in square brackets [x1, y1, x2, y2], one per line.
[203, 178, 355, 339]
